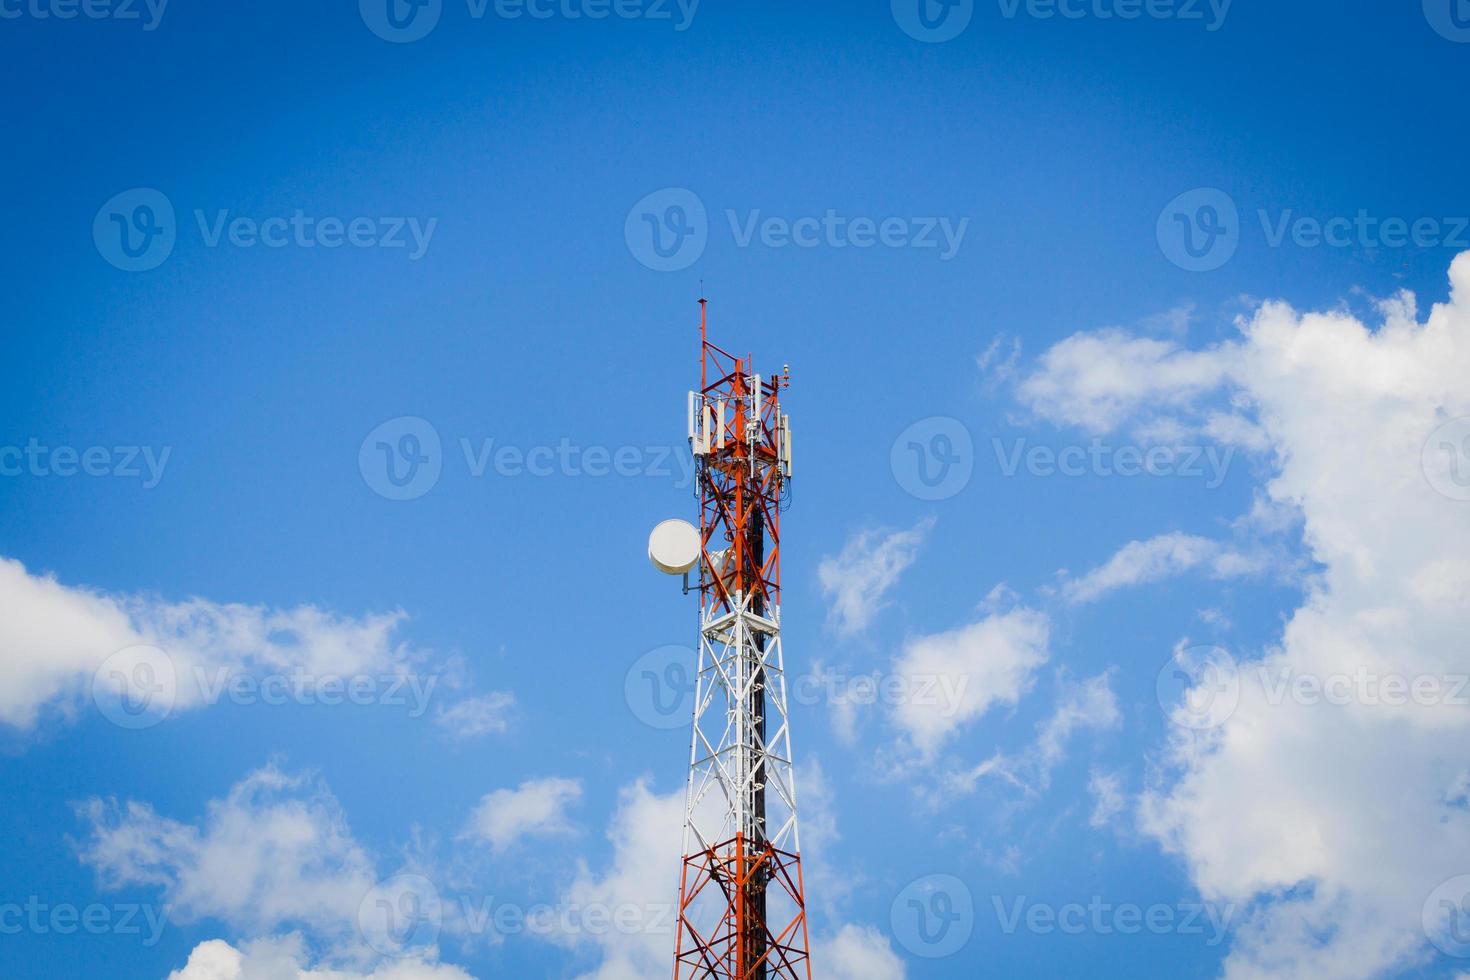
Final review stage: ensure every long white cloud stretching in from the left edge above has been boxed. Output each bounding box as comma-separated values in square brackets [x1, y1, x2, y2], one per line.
[0, 558, 426, 730]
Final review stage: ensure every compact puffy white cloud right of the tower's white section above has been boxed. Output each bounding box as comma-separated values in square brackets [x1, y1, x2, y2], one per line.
[894, 607, 1051, 758]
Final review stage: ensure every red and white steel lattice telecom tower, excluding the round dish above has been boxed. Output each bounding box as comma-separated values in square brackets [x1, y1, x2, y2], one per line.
[658, 300, 811, 980]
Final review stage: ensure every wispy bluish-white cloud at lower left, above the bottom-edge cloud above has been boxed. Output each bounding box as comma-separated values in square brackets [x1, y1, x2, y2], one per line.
[81, 767, 376, 939]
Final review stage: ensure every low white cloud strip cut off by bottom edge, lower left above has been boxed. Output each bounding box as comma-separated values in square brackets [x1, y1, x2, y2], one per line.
[168, 934, 473, 980]
